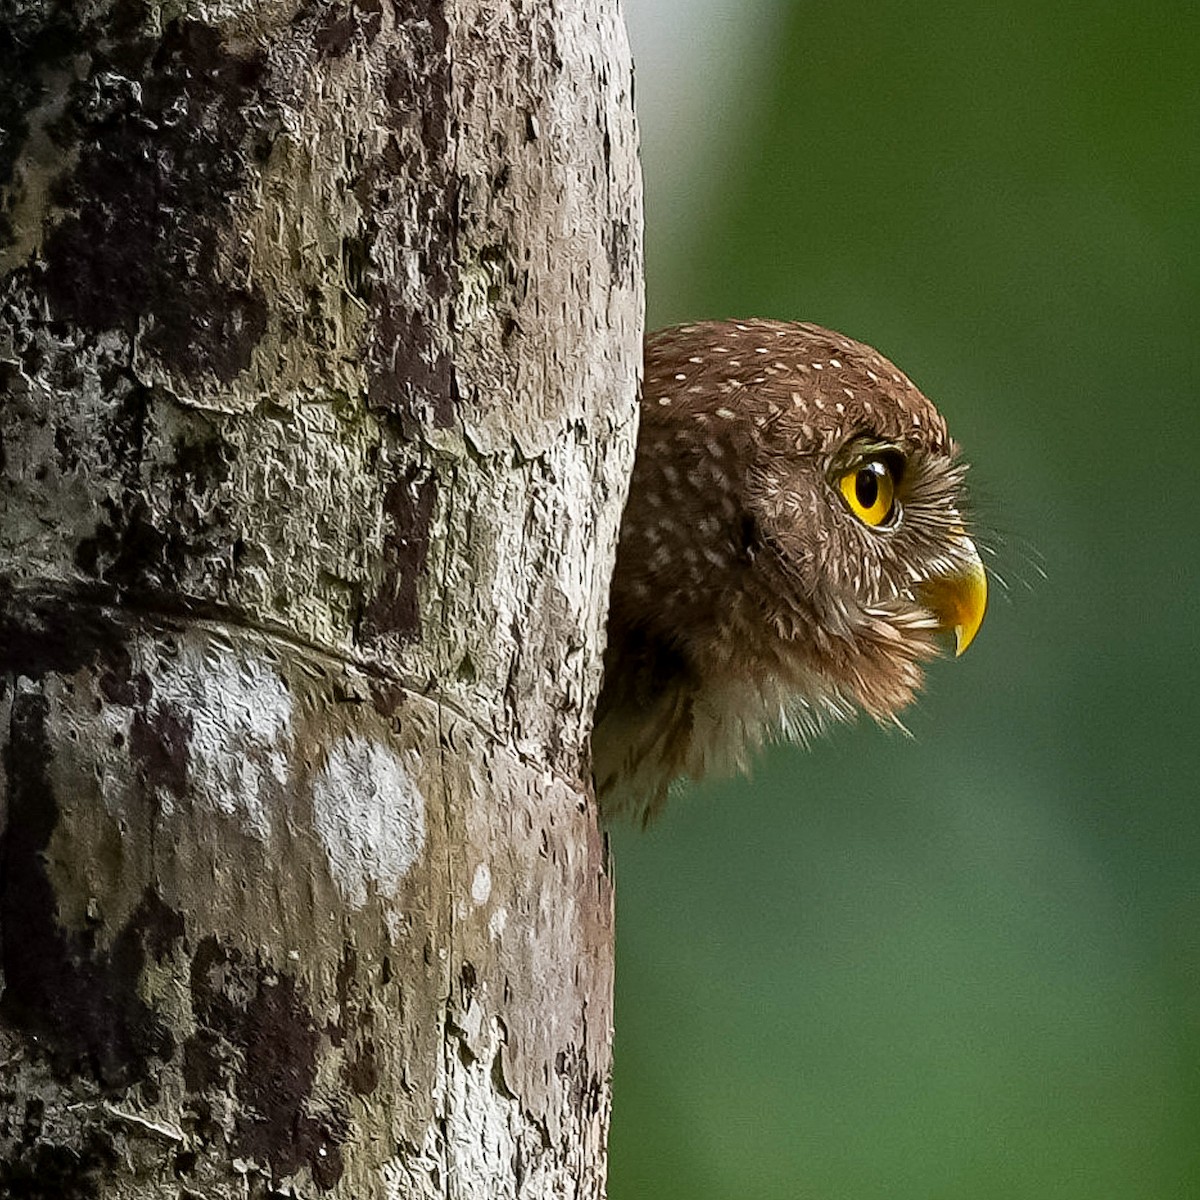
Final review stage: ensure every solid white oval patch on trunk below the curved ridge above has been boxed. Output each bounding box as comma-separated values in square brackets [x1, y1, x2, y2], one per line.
[312, 733, 425, 908]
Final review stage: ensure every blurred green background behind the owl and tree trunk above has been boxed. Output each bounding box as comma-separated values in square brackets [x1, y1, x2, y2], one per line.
[611, 0, 1200, 1200]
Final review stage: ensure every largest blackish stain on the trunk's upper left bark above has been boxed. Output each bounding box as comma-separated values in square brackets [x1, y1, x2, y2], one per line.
[43, 16, 266, 382]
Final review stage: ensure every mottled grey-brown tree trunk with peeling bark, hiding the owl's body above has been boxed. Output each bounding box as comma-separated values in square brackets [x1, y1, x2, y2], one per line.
[0, 0, 642, 1200]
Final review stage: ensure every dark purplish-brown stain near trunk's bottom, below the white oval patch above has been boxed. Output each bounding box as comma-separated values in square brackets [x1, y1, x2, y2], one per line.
[184, 937, 347, 1190]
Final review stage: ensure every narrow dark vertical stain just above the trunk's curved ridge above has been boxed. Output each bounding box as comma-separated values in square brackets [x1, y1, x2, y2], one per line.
[359, 467, 437, 640]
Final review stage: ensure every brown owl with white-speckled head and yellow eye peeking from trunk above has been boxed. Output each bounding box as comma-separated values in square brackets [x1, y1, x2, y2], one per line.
[593, 320, 988, 821]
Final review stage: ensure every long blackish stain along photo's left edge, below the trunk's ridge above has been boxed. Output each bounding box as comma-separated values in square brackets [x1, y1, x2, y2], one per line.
[0, 692, 184, 1090]
